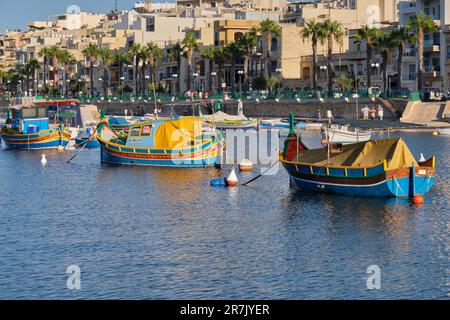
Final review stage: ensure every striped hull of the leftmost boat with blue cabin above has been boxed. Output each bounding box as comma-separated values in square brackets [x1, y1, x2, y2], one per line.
[1, 129, 71, 150]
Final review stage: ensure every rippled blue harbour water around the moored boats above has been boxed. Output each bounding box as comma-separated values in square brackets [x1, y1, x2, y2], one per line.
[0, 133, 450, 299]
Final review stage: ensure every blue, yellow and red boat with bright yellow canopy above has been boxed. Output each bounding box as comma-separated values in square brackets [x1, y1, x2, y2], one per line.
[97, 117, 223, 167]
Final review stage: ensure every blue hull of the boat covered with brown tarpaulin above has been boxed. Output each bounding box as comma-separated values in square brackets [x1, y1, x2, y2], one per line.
[285, 165, 435, 197]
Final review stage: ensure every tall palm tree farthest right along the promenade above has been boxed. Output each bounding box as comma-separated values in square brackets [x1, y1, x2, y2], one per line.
[408, 12, 438, 91]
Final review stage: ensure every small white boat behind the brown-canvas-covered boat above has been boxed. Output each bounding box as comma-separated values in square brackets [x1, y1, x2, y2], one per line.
[322, 124, 372, 144]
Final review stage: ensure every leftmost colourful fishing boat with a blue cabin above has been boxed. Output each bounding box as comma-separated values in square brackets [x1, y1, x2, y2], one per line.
[0, 102, 71, 150]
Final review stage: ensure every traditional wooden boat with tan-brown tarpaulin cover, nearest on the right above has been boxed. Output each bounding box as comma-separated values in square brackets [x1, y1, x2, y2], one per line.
[280, 112, 436, 197]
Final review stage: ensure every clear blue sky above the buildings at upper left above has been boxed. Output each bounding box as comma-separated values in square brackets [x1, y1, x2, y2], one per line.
[0, 0, 150, 33]
